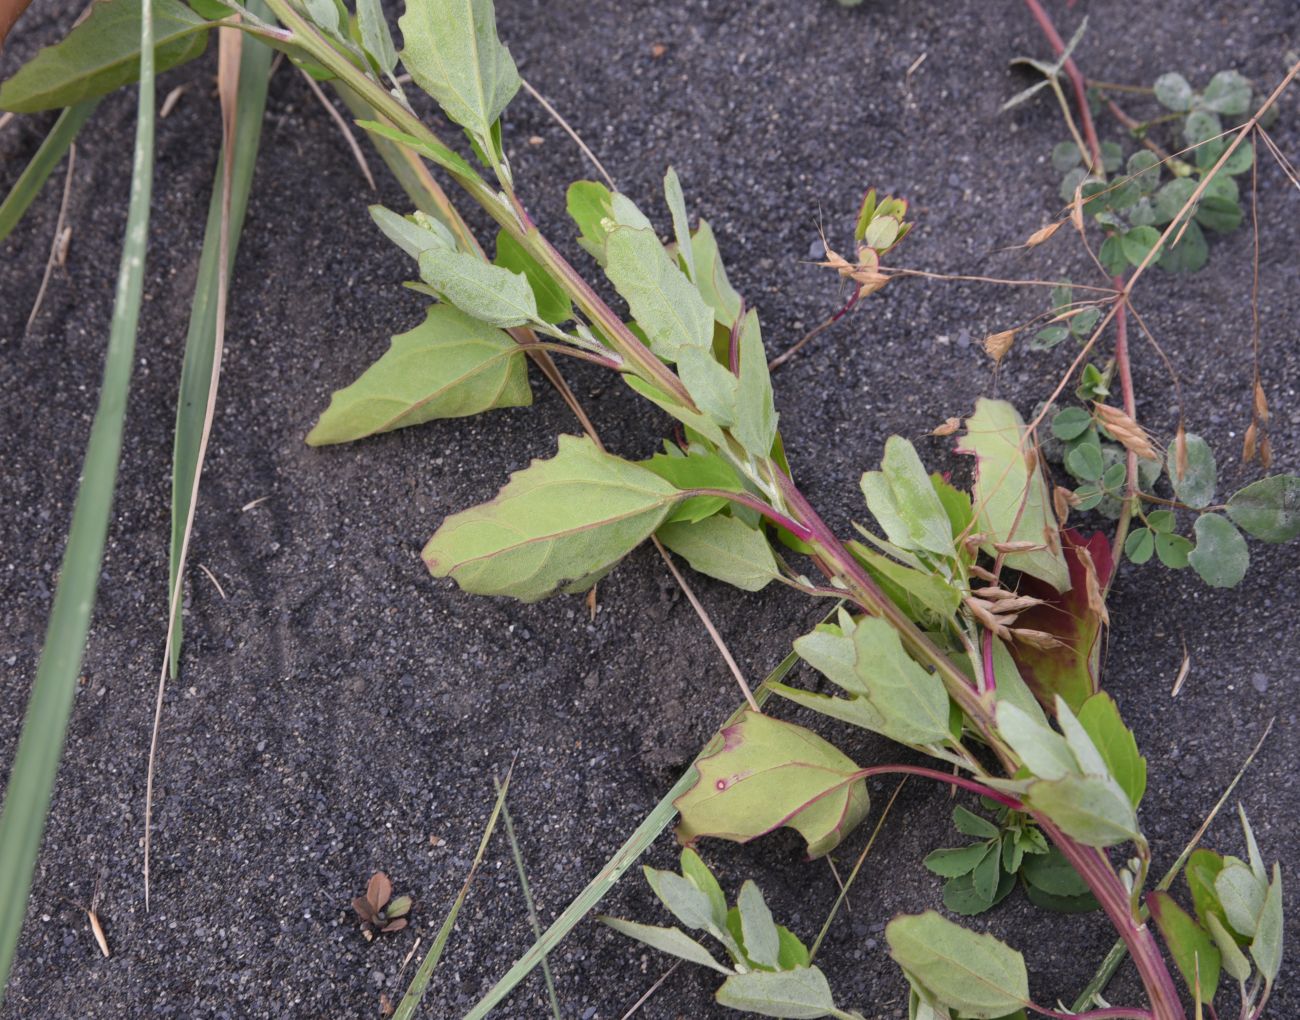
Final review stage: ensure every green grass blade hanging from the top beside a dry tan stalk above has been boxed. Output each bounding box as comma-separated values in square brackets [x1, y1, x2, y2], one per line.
[168, 9, 273, 680]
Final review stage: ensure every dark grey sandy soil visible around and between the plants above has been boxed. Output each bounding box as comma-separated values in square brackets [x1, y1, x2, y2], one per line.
[0, 0, 1300, 1020]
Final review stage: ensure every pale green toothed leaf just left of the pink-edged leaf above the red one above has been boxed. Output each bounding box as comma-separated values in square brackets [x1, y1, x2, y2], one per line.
[862, 435, 953, 556]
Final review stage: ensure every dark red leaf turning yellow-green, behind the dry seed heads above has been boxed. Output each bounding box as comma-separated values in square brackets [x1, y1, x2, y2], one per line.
[1010, 528, 1113, 711]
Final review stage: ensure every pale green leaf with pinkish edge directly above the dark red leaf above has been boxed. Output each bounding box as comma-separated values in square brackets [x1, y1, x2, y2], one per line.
[958, 398, 1070, 591]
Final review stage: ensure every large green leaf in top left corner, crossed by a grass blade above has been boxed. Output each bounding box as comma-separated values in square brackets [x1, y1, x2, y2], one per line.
[0, 0, 211, 113]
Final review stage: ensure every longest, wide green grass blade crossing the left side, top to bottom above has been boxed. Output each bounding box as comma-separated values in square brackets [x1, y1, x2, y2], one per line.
[0, 4, 155, 998]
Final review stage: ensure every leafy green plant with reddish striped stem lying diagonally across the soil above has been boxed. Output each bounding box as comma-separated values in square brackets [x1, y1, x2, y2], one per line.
[7, 0, 1300, 1020]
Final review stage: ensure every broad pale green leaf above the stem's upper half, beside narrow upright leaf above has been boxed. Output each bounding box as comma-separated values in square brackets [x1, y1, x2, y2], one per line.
[605, 226, 714, 361]
